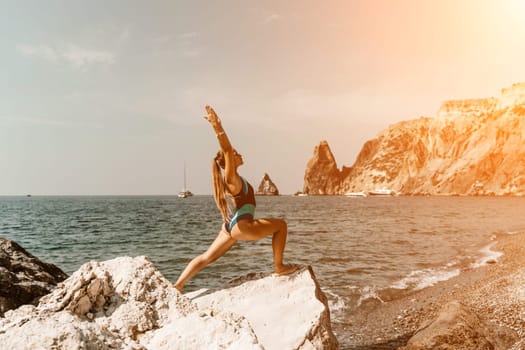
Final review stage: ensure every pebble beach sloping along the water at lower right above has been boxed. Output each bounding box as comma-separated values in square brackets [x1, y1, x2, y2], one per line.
[337, 232, 525, 350]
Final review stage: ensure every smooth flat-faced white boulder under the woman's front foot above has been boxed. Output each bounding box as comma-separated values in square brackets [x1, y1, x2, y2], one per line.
[193, 266, 338, 350]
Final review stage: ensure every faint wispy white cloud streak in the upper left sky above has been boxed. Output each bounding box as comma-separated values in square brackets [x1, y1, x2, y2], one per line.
[17, 44, 115, 68]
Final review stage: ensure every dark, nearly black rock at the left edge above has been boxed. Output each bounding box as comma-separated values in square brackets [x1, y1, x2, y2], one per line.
[0, 237, 67, 317]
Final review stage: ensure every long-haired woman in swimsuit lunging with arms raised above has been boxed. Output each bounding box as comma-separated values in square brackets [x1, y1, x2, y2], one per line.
[175, 106, 298, 291]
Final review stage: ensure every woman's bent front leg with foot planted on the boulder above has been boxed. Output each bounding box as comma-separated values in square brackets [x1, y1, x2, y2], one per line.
[232, 219, 298, 275]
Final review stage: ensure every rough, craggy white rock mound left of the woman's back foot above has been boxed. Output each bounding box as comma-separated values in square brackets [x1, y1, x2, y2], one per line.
[0, 257, 191, 350]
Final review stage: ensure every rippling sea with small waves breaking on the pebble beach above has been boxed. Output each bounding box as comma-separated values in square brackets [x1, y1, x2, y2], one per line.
[0, 195, 525, 344]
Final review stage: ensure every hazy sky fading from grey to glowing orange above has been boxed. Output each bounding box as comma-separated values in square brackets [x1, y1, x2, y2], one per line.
[0, 0, 525, 195]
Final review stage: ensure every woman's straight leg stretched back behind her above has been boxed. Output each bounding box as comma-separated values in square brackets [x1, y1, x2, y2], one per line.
[174, 229, 237, 292]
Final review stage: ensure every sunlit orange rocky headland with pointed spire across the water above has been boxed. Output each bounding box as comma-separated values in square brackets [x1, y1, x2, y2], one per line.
[304, 83, 525, 195]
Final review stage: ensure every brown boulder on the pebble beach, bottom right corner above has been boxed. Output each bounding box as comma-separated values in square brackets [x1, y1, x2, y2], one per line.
[402, 301, 517, 350]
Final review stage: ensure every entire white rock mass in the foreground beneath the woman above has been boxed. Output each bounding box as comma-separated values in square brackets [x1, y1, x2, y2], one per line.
[0, 253, 337, 350]
